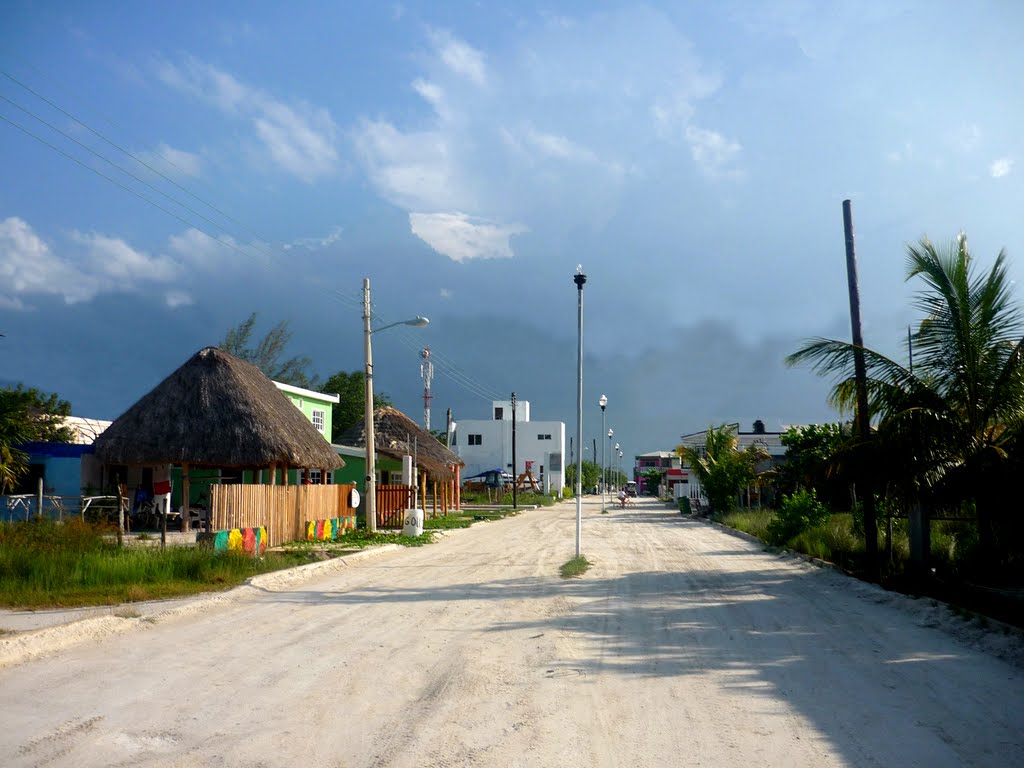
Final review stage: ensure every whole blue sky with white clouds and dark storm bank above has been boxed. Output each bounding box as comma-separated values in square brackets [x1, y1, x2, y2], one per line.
[0, 0, 1024, 462]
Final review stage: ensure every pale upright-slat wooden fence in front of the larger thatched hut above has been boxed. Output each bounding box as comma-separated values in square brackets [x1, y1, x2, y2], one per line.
[210, 483, 355, 547]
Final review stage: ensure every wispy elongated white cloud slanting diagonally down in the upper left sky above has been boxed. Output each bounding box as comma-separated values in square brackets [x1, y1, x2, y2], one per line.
[158, 56, 338, 181]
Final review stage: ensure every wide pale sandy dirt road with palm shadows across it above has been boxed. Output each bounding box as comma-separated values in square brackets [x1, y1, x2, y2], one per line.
[0, 500, 1024, 768]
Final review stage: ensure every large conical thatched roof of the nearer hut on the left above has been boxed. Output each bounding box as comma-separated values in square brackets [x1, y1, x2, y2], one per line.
[95, 347, 344, 469]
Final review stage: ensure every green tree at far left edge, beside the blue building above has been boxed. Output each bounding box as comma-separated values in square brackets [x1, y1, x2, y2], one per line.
[0, 384, 74, 493]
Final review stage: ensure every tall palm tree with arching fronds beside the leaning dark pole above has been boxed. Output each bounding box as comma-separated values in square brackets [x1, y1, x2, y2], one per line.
[786, 233, 1024, 577]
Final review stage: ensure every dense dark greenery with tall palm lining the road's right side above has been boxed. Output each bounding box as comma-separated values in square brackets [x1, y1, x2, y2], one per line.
[677, 234, 1024, 625]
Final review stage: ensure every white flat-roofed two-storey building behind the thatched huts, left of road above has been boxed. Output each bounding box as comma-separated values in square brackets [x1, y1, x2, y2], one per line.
[452, 400, 565, 498]
